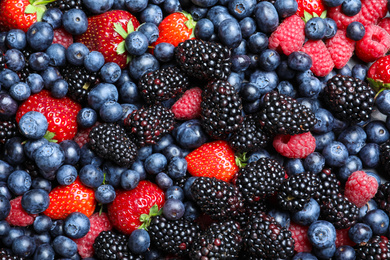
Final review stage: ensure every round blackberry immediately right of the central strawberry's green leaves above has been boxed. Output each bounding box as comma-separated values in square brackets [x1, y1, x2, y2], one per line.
[235, 157, 285, 203]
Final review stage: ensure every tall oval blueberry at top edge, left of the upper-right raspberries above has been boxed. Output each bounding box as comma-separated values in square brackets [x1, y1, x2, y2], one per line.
[254, 1, 279, 33]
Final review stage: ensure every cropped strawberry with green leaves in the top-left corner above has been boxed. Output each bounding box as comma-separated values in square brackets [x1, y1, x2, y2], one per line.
[0, 0, 55, 32]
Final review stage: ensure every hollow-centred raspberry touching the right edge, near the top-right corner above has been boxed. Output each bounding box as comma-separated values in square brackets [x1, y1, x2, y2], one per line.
[355, 25, 390, 62]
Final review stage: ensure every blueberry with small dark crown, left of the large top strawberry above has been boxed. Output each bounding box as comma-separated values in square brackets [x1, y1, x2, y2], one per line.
[62, 8, 88, 35]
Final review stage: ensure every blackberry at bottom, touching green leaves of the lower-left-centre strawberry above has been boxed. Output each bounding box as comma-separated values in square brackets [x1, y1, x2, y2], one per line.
[148, 216, 200, 256]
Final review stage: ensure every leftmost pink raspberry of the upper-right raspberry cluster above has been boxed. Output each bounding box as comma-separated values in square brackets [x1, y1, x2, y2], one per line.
[268, 15, 305, 55]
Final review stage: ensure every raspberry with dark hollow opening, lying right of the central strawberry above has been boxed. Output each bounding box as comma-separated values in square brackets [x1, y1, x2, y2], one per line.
[273, 132, 316, 158]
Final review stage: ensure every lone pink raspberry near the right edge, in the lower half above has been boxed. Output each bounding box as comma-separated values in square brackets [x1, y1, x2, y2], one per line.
[344, 171, 378, 208]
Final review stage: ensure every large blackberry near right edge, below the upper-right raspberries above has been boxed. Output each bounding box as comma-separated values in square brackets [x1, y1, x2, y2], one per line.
[322, 75, 375, 124]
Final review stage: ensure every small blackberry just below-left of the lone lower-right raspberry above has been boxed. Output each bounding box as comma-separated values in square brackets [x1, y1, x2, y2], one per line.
[320, 194, 359, 229]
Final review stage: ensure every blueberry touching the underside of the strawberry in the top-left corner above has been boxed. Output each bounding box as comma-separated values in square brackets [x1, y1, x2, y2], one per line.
[26, 22, 54, 51]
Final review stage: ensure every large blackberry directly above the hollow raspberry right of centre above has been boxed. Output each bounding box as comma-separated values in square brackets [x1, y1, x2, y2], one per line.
[256, 91, 317, 135]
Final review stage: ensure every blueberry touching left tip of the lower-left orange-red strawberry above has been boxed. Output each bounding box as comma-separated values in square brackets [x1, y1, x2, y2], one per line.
[22, 189, 50, 214]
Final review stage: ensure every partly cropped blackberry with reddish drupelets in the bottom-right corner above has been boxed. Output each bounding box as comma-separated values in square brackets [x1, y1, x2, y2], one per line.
[355, 236, 390, 260]
